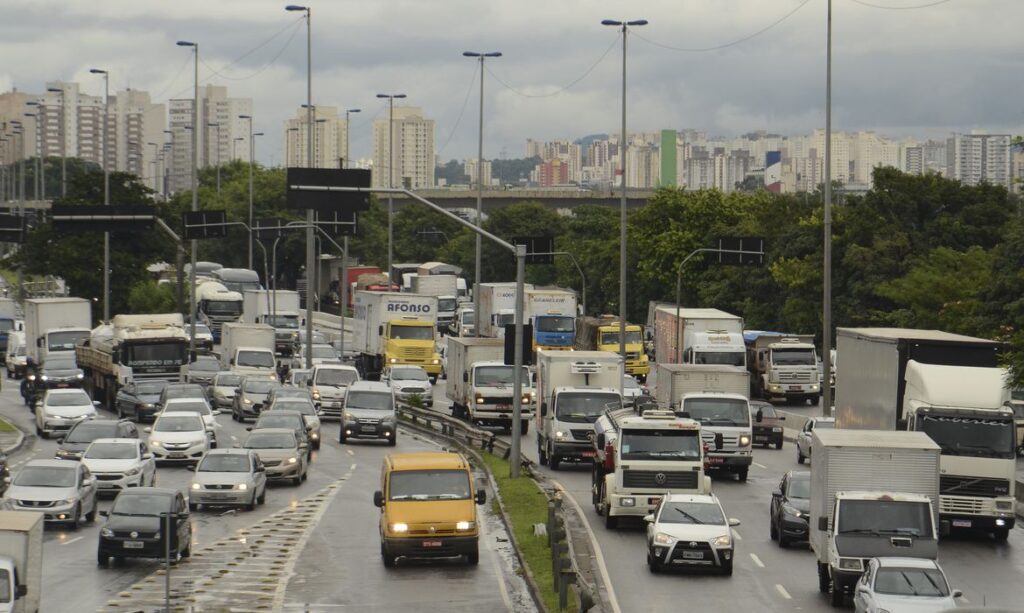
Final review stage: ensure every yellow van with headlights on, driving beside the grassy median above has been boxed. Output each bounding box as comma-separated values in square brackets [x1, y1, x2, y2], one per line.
[374, 451, 487, 568]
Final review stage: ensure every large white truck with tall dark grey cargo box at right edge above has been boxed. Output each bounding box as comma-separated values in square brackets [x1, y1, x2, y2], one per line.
[836, 327, 1016, 540]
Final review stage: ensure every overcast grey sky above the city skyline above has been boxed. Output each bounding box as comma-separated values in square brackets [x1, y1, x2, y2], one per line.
[0, 0, 1024, 164]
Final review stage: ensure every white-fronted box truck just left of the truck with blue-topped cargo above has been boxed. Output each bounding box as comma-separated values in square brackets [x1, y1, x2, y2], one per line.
[654, 304, 746, 366]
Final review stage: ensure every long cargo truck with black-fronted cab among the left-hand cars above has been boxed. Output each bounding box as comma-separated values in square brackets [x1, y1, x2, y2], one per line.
[75, 313, 188, 411]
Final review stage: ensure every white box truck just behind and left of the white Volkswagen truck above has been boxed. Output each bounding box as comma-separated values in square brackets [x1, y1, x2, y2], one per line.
[534, 349, 625, 471]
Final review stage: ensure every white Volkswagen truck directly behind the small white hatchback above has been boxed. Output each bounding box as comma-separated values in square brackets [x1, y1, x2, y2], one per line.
[591, 408, 711, 528]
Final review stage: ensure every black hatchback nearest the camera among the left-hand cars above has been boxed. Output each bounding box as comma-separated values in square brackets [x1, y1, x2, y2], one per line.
[96, 487, 191, 566]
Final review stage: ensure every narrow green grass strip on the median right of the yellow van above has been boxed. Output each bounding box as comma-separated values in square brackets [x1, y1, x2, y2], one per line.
[480, 452, 575, 611]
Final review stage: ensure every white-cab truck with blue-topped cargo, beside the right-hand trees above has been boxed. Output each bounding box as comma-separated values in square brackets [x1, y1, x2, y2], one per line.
[743, 330, 821, 403]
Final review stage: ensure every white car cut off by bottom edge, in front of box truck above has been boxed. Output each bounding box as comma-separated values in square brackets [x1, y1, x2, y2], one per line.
[853, 558, 964, 613]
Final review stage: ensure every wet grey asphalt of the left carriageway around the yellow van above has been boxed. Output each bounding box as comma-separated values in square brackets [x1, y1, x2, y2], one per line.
[0, 380, 532, 611]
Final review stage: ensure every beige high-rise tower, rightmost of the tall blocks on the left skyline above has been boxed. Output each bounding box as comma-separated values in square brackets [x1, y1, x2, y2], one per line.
[373, 106, 434, 189]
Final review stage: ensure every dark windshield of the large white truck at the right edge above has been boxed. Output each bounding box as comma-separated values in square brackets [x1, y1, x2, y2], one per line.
[918, 414, 1016, 459]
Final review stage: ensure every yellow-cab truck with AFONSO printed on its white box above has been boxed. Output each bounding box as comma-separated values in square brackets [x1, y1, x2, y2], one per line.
[352, 292, 441, 380]
